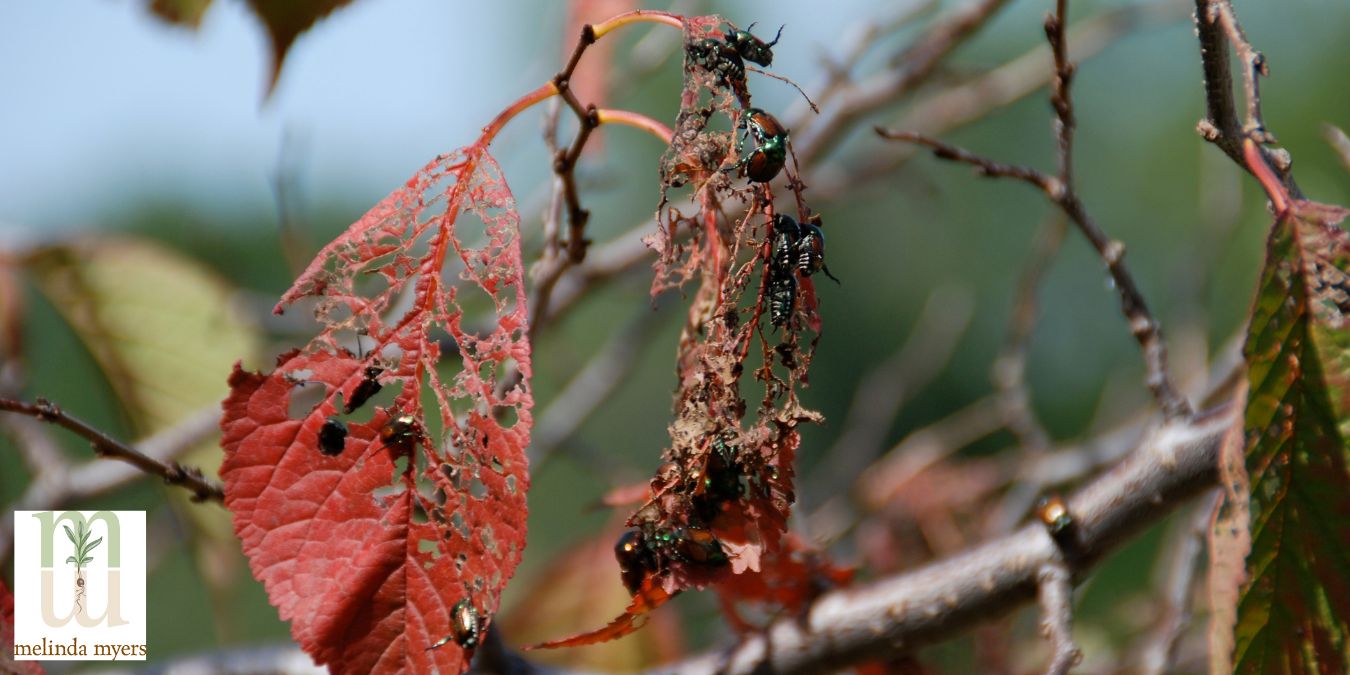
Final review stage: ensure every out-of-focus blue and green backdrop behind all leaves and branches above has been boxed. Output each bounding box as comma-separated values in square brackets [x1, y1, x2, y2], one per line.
[0, 0, 1350, 668]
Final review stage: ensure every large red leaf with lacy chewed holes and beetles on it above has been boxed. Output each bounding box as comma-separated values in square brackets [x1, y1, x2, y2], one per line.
[220, 146, 533, 672]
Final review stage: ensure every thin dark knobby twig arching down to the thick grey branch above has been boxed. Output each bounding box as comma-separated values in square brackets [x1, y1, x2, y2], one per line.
[876, 127, 1191, 420]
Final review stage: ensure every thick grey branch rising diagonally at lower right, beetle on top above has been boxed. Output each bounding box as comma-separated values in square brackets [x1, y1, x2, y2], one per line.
[659, 405, 1241, 675]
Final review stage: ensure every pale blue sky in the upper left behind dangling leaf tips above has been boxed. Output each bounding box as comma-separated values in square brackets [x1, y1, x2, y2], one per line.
[0, 0, 560, 231]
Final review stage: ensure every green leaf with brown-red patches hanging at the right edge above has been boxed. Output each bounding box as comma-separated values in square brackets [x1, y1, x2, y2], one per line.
[1233, 201, 1350, 674]
